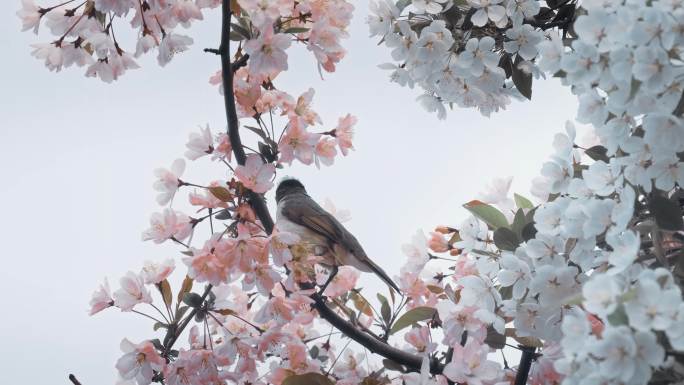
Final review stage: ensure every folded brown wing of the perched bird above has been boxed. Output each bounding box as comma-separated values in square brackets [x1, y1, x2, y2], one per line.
[281, 196, 366, 255]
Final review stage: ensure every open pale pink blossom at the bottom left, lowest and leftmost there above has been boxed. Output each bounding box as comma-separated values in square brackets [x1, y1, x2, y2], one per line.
[116, 338, 166, 385]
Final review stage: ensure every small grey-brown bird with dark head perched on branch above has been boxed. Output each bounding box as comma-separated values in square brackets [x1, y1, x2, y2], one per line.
[276, 179, 401, 293]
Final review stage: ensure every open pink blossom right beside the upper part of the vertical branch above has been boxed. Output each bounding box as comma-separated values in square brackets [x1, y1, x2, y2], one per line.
[245, 23, 292, 79]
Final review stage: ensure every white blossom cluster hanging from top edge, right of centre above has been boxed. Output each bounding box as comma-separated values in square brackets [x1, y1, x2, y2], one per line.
[367, 0, 552, 119]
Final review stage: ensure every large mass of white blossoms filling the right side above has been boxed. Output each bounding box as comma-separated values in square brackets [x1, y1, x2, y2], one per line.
[388, 1, 684, 384]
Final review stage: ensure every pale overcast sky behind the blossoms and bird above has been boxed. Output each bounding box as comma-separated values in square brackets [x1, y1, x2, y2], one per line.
[0, 0, 576, 385]
